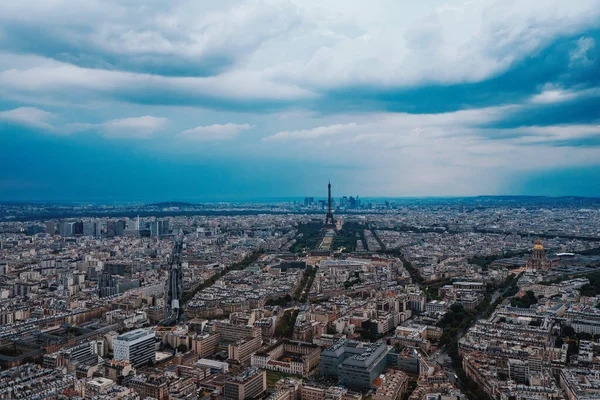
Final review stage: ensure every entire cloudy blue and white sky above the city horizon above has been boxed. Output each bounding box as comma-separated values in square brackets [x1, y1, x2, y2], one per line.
[0, 0, 600, 200]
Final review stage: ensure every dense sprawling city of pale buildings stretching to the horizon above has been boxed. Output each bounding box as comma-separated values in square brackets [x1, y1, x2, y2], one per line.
[0, 186, 600, 400]
